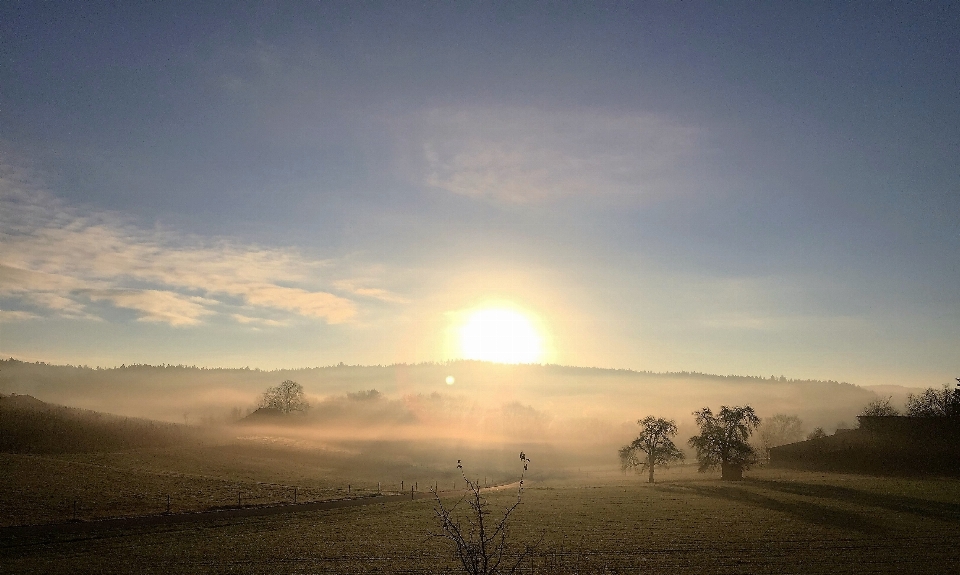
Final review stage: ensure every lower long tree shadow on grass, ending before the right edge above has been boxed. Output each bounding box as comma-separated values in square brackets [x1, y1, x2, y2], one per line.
[656, 485, 884, 535]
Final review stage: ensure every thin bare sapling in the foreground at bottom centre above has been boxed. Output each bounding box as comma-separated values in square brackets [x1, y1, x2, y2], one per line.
[432, 452, 532, 575]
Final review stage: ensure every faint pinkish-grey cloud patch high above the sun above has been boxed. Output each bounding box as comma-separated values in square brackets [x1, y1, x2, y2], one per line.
[404, 108, 698, 203]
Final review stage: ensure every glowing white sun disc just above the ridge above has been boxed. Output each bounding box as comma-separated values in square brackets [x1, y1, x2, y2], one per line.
[460, 308, 543, 363]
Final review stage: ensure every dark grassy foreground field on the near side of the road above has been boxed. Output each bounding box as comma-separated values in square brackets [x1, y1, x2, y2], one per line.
[0, 469, 960, 573]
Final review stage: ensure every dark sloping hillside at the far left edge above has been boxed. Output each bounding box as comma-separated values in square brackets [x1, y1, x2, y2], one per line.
[0, 395, 191, 454]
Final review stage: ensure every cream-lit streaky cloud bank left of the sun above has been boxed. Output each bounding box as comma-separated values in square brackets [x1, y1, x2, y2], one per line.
[0, 158, 390, 326]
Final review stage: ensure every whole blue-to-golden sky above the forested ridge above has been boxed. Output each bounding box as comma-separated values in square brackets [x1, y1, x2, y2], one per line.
[0, 0, 960, 386]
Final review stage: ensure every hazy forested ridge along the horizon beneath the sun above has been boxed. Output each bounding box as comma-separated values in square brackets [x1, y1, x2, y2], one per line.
[0, 359, 878, 436]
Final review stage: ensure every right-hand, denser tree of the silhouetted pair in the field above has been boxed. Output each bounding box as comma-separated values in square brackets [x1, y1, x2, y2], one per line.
[689, 405, 760, 479]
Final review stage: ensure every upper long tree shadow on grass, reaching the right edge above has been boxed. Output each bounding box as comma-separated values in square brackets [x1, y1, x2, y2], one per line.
[747, 479, 960, 523]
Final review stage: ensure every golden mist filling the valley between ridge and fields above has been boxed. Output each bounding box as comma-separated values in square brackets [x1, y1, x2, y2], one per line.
[0, 360, 906, 463]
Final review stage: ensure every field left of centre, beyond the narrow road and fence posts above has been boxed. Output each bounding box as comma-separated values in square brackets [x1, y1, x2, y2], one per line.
[0, 438, 536, 527]
